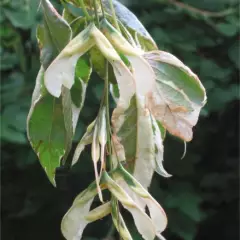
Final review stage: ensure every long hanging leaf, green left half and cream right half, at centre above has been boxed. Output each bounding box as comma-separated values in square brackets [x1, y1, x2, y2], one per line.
[112, 95, 155, 188]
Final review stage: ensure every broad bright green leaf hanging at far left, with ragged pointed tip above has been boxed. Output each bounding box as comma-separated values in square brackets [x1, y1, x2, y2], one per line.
[28, 94, 67, 185]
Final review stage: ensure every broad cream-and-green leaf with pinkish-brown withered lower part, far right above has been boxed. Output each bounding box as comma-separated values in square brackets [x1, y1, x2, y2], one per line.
[145, 51, 206, 141]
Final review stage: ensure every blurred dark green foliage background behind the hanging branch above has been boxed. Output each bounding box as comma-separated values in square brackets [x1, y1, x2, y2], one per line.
[0, 0, 240, 240]
